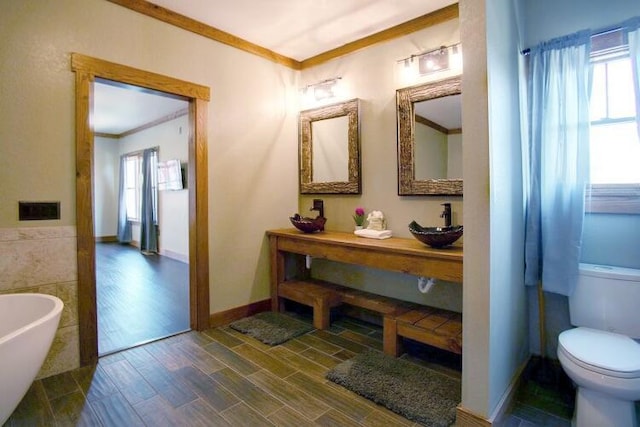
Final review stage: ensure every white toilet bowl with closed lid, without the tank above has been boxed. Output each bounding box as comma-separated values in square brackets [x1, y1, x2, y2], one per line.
[558, 327, 640, 427]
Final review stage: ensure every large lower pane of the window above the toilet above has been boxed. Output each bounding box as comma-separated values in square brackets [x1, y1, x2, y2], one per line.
[590, 122, 640, 184]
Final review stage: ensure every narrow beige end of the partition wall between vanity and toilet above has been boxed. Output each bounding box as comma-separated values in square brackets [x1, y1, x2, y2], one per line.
[460, 0, 493, 417]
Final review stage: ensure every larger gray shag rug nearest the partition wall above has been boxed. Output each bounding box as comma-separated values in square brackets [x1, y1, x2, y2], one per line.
[327, 350, 460, 426]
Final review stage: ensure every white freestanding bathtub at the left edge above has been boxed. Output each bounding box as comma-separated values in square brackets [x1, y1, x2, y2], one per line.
[0, 294, 63, 425]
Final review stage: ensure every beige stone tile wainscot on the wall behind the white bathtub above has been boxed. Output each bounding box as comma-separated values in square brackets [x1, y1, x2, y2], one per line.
[0, 226, 80, 378]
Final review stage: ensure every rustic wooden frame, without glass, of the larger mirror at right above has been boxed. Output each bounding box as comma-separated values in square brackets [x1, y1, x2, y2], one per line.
[396, 76, 462, 196]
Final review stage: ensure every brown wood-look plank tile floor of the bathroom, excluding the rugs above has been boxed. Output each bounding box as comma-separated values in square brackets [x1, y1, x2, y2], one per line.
[4, 310, 570, 427]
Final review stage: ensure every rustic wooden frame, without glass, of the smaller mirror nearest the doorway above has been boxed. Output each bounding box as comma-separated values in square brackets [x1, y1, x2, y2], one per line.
[299, 99, 362, 194]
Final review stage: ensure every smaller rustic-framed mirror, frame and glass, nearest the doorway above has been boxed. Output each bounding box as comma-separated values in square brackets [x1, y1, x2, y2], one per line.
[299, 99, 362, 194]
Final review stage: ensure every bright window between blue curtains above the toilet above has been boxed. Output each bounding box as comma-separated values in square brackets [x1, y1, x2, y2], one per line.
[587, 32, 640, 213]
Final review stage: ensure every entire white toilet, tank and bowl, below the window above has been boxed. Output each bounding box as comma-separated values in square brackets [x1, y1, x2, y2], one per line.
[558, 264, 640, 427]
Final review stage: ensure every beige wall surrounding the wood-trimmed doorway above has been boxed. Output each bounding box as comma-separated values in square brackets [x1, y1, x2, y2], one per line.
[0, 0, 299, 373]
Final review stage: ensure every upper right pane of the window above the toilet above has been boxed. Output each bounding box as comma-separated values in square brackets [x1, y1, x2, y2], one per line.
[607, 58, 636, 118]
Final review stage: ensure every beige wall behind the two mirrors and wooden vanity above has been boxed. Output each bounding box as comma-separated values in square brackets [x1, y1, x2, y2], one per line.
[298, 20, 462, 311]
